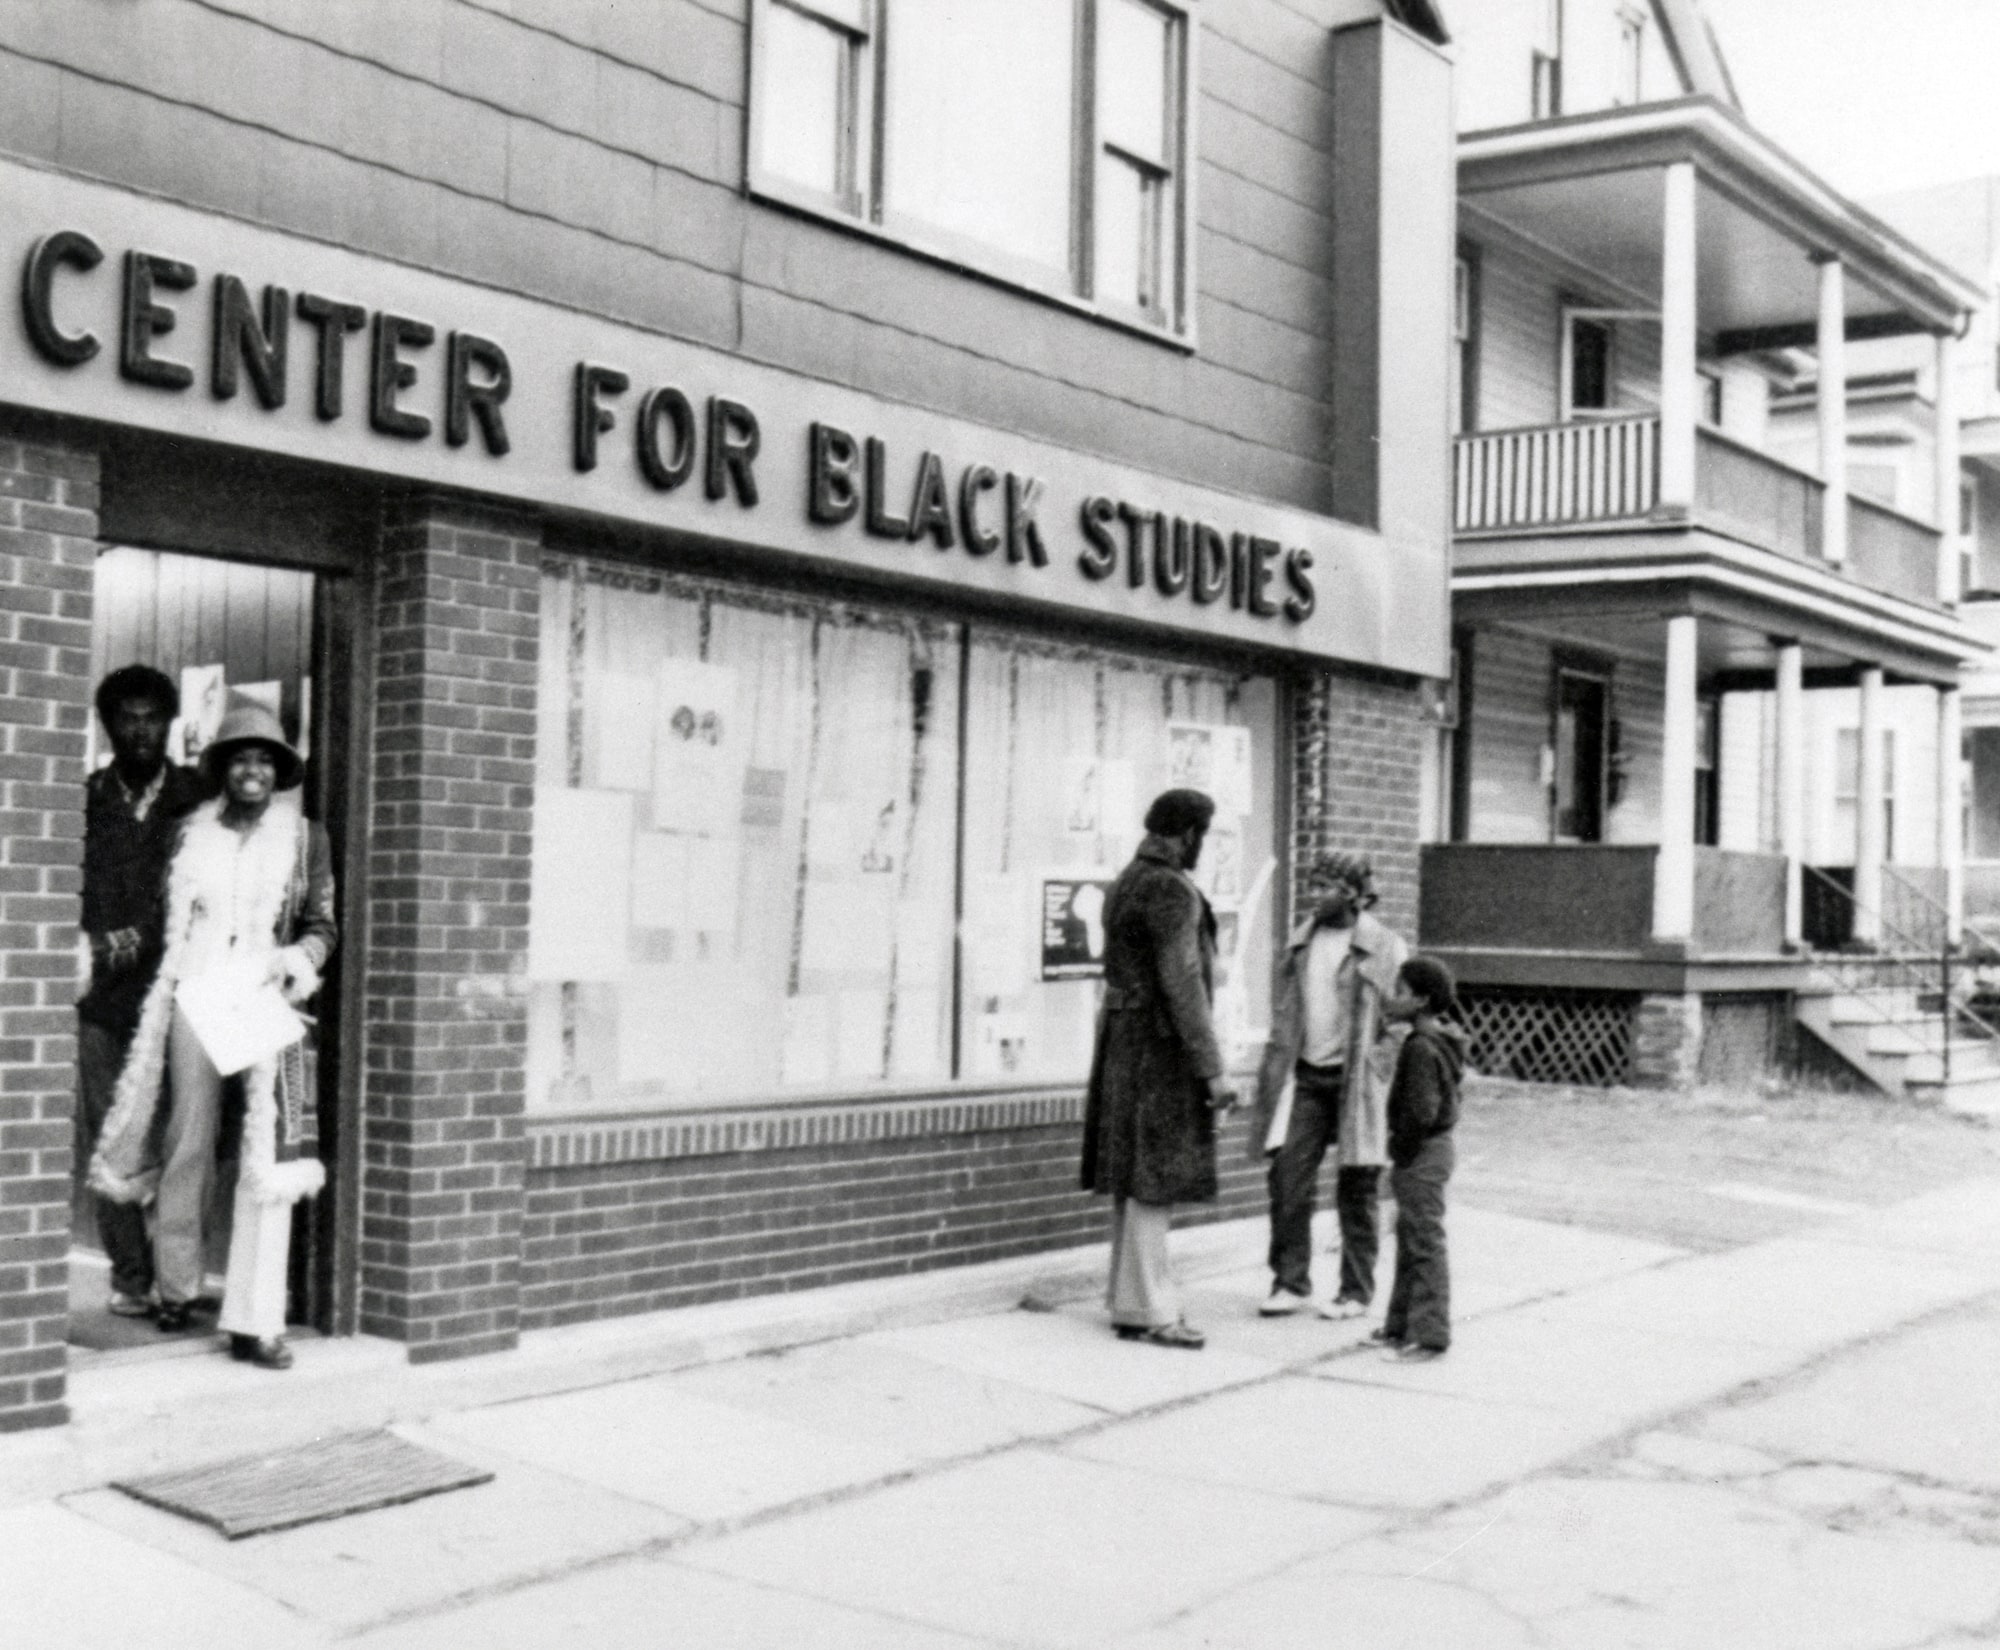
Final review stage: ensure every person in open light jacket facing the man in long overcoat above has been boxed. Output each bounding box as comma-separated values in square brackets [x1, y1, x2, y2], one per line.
[1250, 854, 1410, 1318]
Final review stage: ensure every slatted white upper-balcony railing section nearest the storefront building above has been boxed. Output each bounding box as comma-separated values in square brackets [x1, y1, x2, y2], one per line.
[1452, 412, 1660, 532]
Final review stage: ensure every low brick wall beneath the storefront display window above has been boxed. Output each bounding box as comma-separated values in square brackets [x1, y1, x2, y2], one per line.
[522, 1118, 1264, 1328]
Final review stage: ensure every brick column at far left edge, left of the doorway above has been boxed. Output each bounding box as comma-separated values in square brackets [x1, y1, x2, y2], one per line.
[0, 428, 98, 1432]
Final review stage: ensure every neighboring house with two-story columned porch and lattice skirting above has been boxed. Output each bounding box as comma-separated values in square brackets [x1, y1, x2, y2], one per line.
[1422, 0, 1984, 1104]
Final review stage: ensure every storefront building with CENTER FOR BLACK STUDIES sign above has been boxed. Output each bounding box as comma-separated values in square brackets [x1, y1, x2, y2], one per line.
[0, 0, 1452, 1430]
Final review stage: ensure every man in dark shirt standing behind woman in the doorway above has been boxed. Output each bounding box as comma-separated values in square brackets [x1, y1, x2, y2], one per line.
[76, 664, 202, 1318]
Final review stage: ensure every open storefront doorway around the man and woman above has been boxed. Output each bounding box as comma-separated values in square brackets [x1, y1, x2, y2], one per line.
[70, 546, 352, 1352]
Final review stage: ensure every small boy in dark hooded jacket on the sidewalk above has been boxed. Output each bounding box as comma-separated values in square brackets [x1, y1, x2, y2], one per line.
[1374, 956, 1470, 1362]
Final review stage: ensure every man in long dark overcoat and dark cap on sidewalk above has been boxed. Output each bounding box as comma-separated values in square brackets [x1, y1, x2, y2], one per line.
[1082, 790, 1234, 1348]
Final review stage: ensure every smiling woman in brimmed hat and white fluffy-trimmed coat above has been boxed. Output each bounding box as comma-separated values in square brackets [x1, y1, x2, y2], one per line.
[90, 700, 336, 1370]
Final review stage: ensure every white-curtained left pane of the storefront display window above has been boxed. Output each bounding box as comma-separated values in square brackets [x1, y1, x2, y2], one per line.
[528, 562, 958, 1110]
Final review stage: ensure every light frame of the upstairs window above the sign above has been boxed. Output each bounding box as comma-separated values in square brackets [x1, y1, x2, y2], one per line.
[744, 0, 1202, 352]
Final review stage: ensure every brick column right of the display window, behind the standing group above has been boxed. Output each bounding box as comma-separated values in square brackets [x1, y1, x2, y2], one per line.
[1292, 674, 1424, 940]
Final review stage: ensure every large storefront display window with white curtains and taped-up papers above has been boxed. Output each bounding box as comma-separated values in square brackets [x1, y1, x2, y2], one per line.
[528, 556, 1278, 1114]
